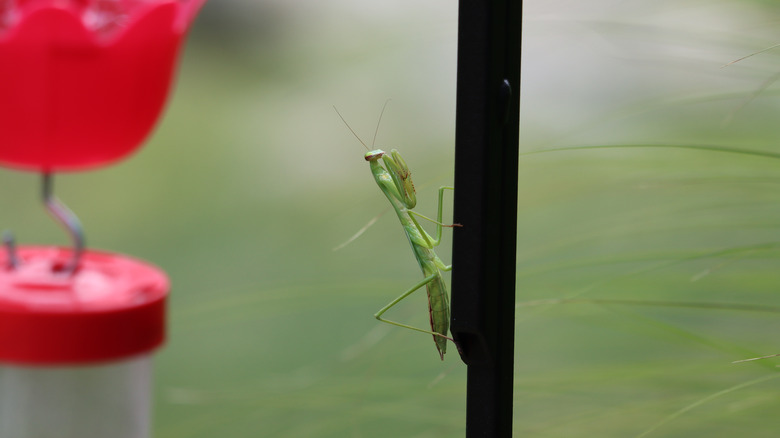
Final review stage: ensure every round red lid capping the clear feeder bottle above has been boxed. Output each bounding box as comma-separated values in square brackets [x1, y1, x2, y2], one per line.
[0, 247, 169, 365]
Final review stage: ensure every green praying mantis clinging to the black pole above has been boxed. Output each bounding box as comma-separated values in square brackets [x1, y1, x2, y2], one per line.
[334, 103, 461, 360]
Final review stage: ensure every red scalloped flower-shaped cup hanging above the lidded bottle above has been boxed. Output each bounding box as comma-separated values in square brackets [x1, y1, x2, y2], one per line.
[0, 0, 205, 172]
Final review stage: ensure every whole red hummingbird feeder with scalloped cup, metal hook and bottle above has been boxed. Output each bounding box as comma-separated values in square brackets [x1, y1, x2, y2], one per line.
[0, 0, 205, 438]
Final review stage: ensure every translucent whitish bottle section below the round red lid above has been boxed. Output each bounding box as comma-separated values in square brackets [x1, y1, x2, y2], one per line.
[0, 356, 152, 438]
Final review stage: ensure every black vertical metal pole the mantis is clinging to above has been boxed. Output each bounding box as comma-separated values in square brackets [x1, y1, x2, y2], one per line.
[451, 0, 522, 438]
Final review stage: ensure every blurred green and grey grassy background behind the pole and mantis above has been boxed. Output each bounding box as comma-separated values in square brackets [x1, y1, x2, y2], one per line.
[0, 0, 780, 438]
